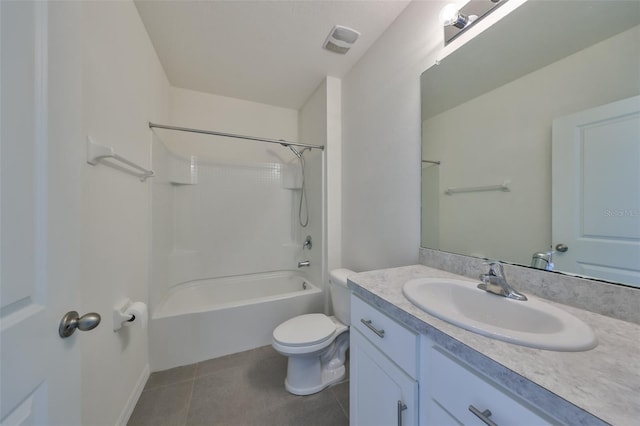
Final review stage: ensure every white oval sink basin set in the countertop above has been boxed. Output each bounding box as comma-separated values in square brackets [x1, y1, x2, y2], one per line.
[402, 278, 598, 351]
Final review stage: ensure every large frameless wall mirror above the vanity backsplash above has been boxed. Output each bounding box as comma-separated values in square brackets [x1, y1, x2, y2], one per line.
[421, 0, 640, 286]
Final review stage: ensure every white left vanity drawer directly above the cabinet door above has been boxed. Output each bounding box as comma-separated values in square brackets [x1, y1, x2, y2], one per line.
[351, 295, 418, 378]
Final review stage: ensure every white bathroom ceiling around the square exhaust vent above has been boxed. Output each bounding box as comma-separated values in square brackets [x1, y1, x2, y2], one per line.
[135, 0, 409, 109]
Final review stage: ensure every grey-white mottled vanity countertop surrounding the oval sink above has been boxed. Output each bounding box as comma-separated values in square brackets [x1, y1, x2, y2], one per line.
[349, 265, 640, 426]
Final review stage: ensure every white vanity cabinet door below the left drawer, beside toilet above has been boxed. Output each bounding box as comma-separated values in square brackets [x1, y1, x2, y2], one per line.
[350, 328, 418, 426]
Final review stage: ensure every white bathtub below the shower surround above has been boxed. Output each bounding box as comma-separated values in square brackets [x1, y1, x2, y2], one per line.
[149, 271, 325, 371]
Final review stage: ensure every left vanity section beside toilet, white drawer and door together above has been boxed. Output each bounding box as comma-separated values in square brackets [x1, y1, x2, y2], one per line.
[349, 296, 419, 426]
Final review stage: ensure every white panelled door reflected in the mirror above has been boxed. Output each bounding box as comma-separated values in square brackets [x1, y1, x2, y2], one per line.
[552, 96, 640, 286]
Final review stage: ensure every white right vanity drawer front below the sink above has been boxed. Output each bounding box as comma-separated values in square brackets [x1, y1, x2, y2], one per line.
[427, 346, 559, 426]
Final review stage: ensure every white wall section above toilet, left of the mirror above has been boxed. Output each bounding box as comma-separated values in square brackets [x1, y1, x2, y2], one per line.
[342, 1, 445, 271]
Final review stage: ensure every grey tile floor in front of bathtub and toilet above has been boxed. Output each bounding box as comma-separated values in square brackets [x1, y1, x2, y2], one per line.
[128, 346, 349, 426]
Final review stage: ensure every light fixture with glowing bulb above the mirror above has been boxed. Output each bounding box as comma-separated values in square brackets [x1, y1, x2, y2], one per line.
[440, 0, 508, 46]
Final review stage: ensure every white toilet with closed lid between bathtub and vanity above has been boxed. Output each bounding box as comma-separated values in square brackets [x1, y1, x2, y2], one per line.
[271, 269, 354, 395]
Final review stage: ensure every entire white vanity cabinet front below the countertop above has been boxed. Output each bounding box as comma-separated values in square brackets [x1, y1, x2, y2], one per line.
[350, 295, 561, 426]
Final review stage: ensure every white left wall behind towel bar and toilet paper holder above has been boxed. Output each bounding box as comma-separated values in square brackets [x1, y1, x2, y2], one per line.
[79, 2, 169, 425]
